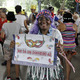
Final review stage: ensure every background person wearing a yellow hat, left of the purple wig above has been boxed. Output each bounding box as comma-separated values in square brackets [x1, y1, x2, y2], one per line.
[28, 5, 37, 24]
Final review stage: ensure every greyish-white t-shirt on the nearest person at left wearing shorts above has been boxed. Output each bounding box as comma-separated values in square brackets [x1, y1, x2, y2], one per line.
[2, 22, 21, 44]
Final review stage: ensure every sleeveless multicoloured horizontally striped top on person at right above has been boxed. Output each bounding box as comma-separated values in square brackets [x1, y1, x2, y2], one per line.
[61, 23, 76, 50]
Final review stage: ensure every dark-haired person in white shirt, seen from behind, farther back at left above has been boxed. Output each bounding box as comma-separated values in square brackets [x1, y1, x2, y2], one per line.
[15, 5, 29, 33]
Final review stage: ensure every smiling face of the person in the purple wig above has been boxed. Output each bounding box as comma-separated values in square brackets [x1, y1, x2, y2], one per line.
[38, 15, 51, 30]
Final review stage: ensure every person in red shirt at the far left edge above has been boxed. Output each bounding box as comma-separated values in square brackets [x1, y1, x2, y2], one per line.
[0, 8, 7, 66]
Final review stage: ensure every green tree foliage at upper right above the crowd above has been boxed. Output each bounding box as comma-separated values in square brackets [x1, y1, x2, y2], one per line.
[37, 0, 76, 12]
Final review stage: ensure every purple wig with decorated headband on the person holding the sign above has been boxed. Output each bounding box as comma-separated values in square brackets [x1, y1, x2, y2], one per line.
[30, 10, 56, 34]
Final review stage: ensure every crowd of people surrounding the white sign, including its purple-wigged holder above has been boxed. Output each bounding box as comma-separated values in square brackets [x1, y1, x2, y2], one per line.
[0, 5, 80, 80]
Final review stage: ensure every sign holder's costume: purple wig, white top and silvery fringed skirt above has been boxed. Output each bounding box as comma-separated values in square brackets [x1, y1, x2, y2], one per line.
[27, 10, 64, 80]
